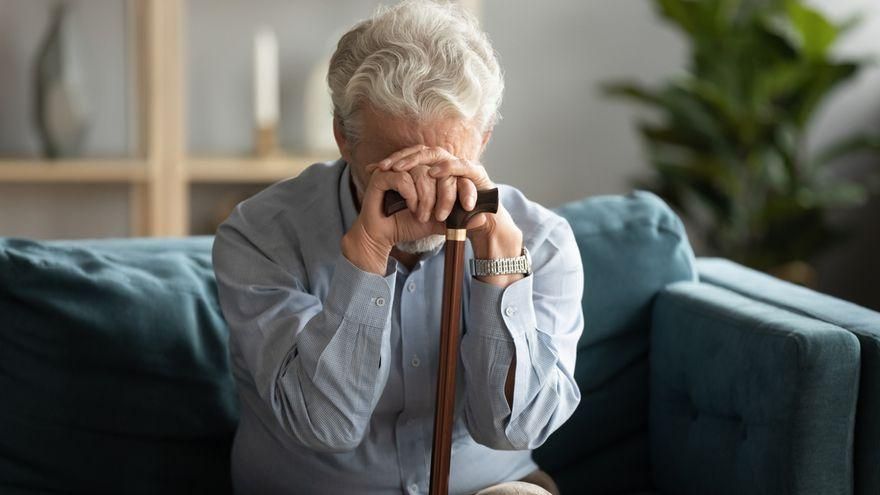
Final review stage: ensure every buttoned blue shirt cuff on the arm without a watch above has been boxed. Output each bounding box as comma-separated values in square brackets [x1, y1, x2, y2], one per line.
[324, 254, 397, 328]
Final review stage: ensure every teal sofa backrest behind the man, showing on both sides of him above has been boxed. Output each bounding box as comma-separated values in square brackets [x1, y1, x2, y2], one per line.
[0, 192, 695, 494]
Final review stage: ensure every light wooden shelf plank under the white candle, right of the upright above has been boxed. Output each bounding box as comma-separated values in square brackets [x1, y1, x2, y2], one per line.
[186, 155, 332, 184]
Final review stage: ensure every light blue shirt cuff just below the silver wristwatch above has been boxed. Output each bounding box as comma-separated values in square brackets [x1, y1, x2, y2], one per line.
[468, 275, 537, 340]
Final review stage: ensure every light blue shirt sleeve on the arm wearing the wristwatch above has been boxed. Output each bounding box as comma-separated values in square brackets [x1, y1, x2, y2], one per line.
[461, 222, 583, 450]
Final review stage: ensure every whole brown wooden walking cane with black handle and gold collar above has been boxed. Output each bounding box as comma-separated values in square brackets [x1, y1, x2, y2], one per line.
[384, 188, 498, 495]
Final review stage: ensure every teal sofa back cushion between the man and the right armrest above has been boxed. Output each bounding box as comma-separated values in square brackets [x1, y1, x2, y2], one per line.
[535, 191, 696, 494]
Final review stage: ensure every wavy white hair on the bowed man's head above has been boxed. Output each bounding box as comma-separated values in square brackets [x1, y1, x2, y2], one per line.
[327, 0, 504, 141]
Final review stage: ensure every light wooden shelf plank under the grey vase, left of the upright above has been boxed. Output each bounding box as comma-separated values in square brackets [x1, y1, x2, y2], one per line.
[0, 159, 147, 183]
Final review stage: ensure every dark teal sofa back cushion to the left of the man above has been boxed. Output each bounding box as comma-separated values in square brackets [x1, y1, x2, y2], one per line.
[0, 237, 237, 493]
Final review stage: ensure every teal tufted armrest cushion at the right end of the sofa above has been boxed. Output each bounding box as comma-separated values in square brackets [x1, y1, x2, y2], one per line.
[649, 282, 859, 495]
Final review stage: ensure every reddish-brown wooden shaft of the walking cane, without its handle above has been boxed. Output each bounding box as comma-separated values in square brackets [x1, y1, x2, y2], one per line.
[429, 235, 465, 495]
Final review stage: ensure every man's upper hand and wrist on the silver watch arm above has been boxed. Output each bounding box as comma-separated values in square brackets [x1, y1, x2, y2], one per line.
[367, 147, 523, 287]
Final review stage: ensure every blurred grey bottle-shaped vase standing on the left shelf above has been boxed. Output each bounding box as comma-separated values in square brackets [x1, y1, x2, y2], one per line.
[34, 3, 89, 158]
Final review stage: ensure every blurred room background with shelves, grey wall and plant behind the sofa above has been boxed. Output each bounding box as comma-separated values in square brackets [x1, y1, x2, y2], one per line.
[0, 0, 880, 309]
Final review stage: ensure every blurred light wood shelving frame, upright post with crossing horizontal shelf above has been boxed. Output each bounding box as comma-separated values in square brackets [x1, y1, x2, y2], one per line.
[0, 0, 481, 237]
